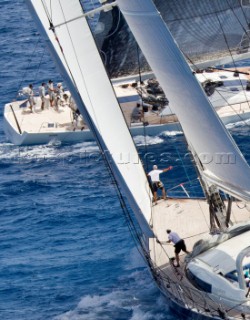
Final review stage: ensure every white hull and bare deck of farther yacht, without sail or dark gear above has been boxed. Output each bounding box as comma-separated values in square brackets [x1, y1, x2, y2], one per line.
[4, 70, 250, 145]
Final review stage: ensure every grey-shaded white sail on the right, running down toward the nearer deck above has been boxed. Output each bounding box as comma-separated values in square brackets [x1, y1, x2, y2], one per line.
[117, 0, 250, 201]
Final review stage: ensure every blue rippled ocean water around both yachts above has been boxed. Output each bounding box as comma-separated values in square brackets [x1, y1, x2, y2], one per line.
[0, 0, 250, 320]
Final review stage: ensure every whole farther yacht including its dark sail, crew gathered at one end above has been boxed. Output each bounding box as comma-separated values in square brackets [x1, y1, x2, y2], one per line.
[4, 0, 250, 145]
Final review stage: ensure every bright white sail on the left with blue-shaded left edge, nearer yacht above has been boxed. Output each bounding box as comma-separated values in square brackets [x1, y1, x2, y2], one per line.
[26, 0, 152, 236]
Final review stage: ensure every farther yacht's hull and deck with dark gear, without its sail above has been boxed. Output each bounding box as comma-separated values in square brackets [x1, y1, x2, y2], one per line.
[4, 68, 250, 145]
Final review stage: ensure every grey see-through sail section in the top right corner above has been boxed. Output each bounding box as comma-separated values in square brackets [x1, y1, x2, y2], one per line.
[155, 0, 250, 67]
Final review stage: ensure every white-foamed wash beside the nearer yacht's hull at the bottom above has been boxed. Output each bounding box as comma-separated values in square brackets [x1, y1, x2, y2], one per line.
[54, 271, 172, 320]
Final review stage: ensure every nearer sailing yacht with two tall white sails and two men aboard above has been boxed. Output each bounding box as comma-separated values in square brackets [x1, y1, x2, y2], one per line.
[23, 0, 250, 319]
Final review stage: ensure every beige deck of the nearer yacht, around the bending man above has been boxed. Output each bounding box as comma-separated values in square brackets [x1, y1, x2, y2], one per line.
[150, 199, 250, 319]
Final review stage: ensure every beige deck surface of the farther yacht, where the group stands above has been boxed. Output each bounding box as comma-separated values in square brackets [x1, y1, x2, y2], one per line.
[5, 94, 250, 133]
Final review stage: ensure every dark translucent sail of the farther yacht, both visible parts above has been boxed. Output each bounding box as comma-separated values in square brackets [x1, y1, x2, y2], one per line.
[86, 0, 250, 78]
